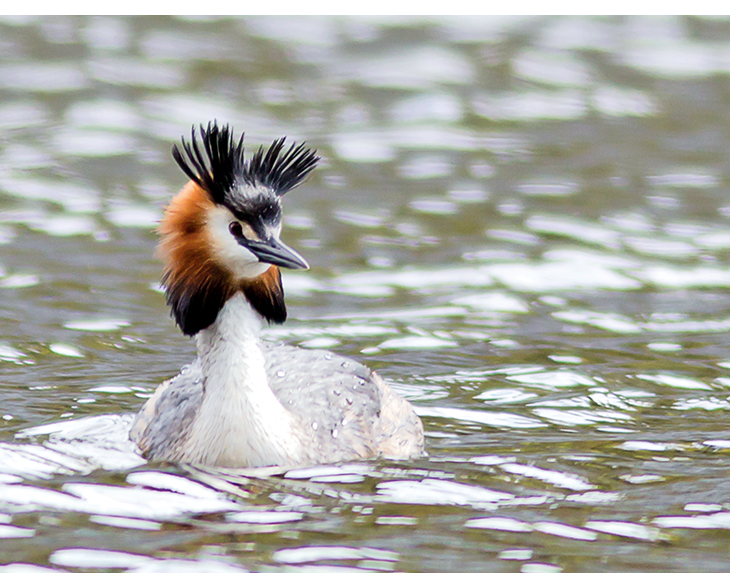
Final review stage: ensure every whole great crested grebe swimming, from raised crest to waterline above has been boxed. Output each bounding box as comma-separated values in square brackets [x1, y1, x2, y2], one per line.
[130, 122, 424, 467]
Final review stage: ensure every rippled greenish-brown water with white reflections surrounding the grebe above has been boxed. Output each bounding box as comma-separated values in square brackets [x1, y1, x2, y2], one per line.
[0, 17, 730, 572]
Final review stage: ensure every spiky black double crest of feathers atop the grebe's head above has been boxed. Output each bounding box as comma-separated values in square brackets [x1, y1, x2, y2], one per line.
[172, 122, 320, 204]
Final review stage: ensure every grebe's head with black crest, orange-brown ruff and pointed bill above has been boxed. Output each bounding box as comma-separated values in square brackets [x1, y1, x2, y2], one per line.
[159, 123, 319, 335]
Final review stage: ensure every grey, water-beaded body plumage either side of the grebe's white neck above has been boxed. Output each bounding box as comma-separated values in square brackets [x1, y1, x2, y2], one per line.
[131, 342, 424, 465]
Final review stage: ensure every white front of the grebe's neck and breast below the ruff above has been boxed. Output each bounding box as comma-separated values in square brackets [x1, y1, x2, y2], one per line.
[185, 293, 302, 467]
